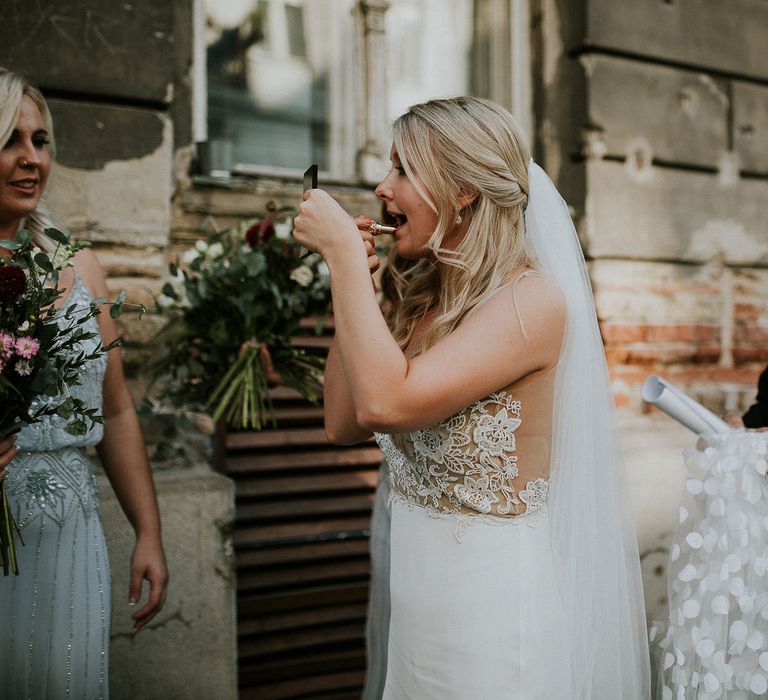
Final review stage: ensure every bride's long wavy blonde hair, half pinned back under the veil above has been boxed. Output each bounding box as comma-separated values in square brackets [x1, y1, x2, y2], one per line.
[390, 97, 535, 354]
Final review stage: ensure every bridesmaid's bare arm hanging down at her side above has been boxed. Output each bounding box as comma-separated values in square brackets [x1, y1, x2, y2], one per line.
[75, 250, 168, 630]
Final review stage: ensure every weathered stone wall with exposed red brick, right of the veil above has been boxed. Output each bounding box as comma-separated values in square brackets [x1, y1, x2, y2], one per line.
[534, 0, 768, 617]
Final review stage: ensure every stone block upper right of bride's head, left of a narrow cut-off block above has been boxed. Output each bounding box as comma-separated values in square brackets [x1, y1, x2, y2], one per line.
[581, 54, 729, 167]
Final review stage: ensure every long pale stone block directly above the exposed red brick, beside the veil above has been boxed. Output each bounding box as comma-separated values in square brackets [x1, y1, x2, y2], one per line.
[582, 160, 768, 265]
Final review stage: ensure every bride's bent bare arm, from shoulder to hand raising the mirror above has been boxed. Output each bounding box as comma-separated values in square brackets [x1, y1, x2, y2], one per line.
[294, 190, 565, 432]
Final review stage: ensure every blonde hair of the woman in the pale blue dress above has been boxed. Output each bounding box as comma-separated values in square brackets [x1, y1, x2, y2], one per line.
[0, 66, 56, 252]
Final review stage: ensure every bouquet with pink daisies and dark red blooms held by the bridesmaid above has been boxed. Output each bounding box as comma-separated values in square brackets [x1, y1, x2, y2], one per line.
[0, 228, 135, 576]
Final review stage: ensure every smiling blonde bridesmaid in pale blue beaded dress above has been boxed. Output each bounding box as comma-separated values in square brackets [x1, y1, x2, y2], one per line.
[0, 68, 168, 700]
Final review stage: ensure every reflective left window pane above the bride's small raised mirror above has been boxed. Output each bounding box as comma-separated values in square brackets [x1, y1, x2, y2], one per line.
[206, 0, 350, 170]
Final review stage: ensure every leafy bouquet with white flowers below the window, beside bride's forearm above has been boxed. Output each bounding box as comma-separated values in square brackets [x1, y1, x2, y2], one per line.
[151, 209, 330, 430]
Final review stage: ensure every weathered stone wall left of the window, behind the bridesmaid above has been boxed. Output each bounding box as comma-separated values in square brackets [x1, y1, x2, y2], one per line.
[0, 0, 237, 699]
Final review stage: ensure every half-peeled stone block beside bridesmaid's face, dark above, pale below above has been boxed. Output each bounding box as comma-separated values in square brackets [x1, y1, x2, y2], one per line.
[47, 103, 173, 247]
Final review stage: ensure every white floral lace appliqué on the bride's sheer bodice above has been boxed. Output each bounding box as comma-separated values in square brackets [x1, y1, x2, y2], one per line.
[376, 392, 549, 537]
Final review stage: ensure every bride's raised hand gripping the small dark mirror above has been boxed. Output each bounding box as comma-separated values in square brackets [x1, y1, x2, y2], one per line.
[293, 190, 360, 260]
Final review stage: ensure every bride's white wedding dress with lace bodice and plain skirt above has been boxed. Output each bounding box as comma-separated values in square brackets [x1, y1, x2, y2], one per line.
[376, 370, 571, 700]
